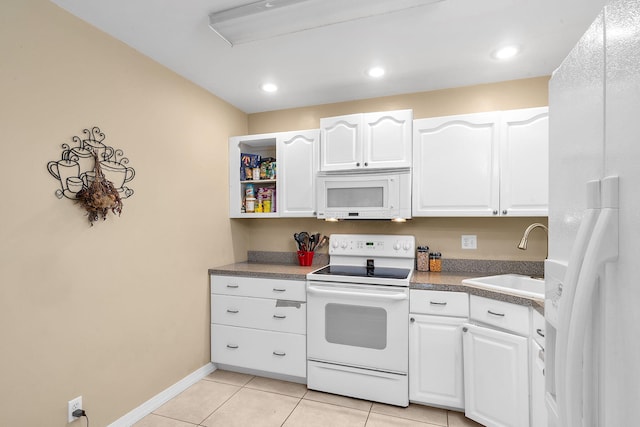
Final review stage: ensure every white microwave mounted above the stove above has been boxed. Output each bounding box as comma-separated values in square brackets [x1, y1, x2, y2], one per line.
[317, 170, 411, 219]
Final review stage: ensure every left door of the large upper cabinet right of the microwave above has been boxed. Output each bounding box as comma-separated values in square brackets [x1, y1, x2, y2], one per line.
[412, 112, 500, 216]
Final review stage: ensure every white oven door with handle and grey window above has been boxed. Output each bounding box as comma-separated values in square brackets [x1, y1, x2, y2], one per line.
[307, 281, 409, 374]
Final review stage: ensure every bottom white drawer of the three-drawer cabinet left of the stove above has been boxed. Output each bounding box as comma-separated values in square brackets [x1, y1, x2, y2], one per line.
[211, 324, 307, 377]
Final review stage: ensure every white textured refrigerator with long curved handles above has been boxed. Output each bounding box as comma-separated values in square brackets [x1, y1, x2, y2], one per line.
[545, 0, 640, 427]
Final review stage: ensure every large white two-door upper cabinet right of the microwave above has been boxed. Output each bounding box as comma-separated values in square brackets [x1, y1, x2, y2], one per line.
[412, 107, 549, 216]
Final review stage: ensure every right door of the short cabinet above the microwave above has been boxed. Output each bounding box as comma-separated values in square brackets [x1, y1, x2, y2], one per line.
[363, 110, 413, 169]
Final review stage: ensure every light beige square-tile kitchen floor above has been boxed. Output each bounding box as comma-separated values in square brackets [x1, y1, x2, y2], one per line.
[135, 370, 480, 427]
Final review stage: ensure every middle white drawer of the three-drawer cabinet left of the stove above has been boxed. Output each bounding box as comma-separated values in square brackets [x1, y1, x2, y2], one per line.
[211, 294, 307, 335]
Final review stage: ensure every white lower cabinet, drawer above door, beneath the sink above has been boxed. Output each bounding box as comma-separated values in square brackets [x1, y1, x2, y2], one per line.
[462, 295, 530, 427]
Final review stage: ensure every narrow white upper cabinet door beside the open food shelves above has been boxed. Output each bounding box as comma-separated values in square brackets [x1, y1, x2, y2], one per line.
[276, 130, 320, 217]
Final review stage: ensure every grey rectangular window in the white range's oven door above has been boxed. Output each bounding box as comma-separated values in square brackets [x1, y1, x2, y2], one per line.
[324, 304, 387, 350]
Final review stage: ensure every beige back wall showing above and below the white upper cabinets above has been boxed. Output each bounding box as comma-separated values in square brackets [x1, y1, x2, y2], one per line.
[245, 77, 549, 261]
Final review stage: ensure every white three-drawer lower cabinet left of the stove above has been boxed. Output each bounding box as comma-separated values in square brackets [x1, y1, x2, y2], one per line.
[211, 275, 307, 379]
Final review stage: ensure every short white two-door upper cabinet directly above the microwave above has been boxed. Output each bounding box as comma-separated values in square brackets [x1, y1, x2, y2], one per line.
[320, 110, 413, 172]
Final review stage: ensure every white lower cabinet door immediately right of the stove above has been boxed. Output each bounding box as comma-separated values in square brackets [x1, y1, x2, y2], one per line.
[409, 314, 467, 409]
